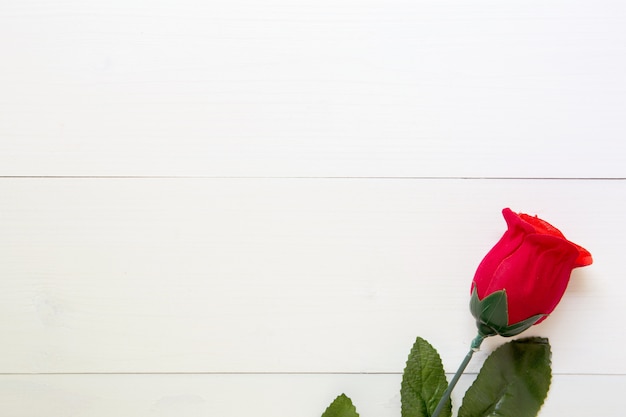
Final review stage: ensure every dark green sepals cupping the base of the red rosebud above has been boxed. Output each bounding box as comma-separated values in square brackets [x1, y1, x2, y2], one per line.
[470, 287, 544, 337]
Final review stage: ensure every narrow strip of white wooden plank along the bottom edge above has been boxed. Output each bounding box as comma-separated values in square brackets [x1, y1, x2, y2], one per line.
[0, 374, 626, 417]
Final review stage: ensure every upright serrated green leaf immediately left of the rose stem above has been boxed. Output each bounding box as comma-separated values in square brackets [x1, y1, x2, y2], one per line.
[400, 337, 452, 417]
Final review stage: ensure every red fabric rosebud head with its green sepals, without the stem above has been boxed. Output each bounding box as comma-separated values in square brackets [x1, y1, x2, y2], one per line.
[470, 208, 592, 336]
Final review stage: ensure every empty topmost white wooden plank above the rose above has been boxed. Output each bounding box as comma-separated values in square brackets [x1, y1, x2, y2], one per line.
[0, 0, 626, 178]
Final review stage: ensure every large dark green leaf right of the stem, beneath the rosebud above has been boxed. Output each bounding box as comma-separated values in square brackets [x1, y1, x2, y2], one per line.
[459, 337, 552, 417]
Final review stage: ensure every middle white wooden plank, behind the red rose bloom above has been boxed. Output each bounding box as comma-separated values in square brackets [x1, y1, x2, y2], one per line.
[0, 178, 626, 375]
